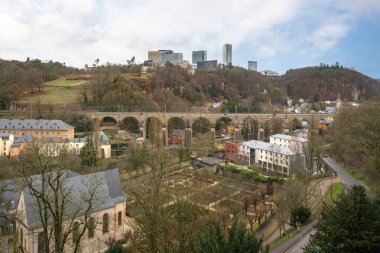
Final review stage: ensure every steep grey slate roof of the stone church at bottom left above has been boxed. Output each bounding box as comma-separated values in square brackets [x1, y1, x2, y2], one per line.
[23, 169, 126, 229]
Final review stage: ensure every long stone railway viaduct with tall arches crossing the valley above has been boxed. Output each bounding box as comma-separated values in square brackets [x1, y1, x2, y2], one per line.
[84, 112, 331, 145]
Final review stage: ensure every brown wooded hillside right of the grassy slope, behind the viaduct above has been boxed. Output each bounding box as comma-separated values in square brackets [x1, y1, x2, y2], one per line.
[92, 65, 380, 112]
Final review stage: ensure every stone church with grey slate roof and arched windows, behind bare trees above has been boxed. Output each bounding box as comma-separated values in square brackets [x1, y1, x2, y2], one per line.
[8, 169, 127, 253]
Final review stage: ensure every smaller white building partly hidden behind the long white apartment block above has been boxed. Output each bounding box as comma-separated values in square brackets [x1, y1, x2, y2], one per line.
[269, 134, 309, 154]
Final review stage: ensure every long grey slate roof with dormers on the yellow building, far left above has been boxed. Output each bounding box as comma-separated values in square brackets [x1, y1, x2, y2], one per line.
[0, 119, 74, 131]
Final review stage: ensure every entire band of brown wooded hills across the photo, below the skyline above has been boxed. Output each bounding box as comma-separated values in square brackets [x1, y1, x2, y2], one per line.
[0, 58, 380, 113]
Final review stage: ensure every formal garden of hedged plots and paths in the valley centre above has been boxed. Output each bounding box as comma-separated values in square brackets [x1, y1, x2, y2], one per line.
[123, 168, 274, 232]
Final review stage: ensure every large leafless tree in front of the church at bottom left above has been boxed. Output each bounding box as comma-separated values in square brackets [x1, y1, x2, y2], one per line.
[18, 143, 101, 253]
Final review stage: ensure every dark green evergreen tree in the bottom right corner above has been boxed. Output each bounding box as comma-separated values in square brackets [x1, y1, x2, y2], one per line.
[305, 186, 380, 253]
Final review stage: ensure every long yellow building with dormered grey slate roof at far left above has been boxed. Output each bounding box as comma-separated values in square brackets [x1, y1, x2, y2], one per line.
[0, 119, 74, 138]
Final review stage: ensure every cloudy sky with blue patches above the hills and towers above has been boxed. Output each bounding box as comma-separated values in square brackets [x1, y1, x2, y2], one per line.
[0, 0, 380, 78]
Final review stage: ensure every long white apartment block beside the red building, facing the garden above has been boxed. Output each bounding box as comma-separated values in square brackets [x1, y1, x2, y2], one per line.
[239, 140, 305, 175]
